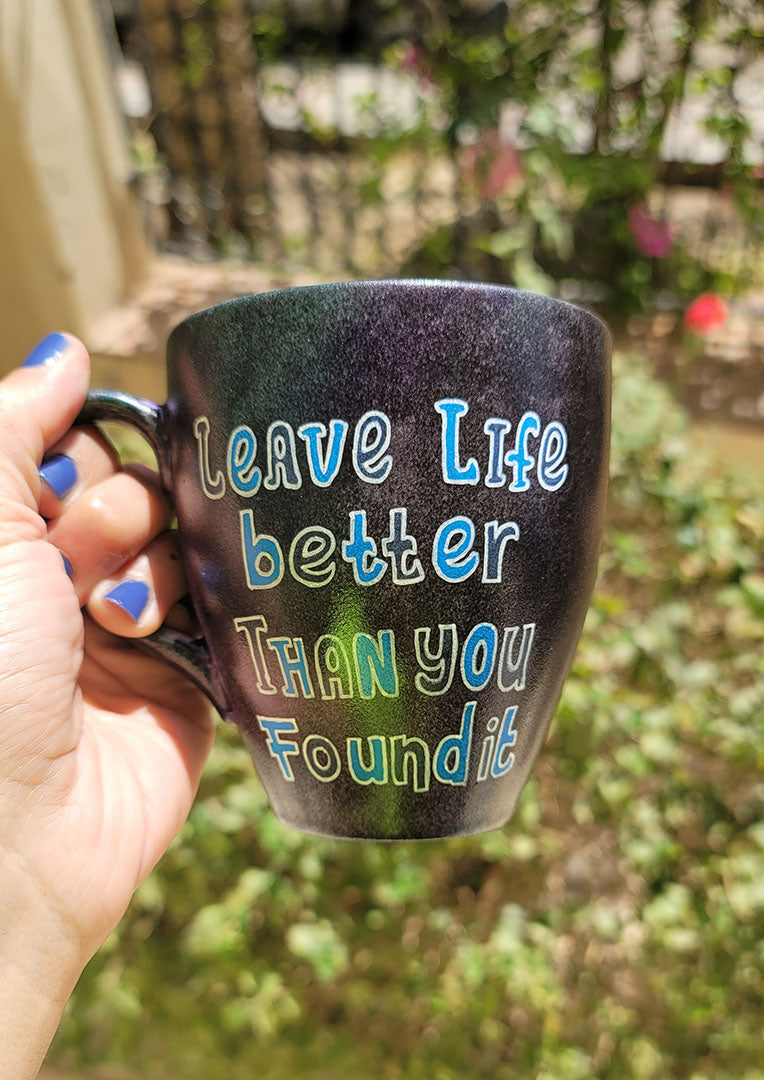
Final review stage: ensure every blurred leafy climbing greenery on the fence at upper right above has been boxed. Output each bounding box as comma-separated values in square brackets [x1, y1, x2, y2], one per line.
[391, 0, 764, 315]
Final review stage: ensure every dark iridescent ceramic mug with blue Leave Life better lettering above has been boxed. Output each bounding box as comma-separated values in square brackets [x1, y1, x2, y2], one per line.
[82, 281, 609, 839]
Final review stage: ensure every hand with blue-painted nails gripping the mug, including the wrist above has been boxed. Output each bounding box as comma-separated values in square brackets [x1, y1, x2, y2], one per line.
[0, 335, 213, 1080]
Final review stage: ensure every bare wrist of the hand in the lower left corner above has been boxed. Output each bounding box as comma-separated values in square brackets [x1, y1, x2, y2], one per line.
[0, 853, 89, 1080]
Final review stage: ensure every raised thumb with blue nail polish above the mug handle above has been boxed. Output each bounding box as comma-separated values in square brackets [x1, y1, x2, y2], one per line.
[0, 334, 90, 548]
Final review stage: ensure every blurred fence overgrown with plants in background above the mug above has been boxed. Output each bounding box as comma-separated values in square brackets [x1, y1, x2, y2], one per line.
[116, 0, 764, 313]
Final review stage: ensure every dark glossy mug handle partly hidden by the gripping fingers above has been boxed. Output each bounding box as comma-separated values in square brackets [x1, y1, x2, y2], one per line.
[75, 390, 230, 718]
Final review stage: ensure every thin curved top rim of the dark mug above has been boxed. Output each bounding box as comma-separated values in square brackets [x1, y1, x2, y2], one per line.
[167, 278, 612, 345]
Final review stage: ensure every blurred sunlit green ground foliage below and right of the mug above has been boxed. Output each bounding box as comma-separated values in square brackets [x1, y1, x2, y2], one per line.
[55, 356, 764, 1080]
